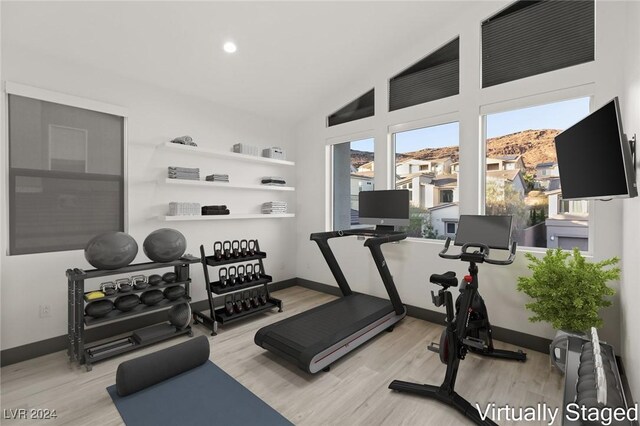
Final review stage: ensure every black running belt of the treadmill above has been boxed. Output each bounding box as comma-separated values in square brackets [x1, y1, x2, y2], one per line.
[255, 294, 393, 368]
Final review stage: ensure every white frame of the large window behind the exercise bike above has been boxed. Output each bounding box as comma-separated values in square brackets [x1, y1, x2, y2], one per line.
[478, 83, 597, 256]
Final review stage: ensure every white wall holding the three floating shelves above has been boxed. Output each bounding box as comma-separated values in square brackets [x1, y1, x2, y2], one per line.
[0, 42, 296, 349]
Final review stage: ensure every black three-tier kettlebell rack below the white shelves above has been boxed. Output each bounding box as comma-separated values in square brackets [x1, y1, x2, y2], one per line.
[193, 240, 282, 336]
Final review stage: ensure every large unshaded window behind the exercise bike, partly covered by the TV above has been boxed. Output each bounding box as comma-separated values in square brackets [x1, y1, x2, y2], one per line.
[485, 98, 592, 251]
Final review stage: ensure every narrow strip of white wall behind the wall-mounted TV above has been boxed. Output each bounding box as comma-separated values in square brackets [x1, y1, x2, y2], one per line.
[620, 2, 640, 401]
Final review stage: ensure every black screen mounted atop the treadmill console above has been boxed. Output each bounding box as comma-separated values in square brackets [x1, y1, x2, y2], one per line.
[358, 189, 409, 226]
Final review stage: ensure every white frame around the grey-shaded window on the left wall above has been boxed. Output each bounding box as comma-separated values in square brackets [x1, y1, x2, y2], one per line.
[2, 81, 129, 256]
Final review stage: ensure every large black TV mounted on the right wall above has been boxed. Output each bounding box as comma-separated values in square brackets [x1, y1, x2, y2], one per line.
[555, 98, 638, 199]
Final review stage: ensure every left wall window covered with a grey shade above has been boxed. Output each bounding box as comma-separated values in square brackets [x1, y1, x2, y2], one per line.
[9, 94, 124, 255]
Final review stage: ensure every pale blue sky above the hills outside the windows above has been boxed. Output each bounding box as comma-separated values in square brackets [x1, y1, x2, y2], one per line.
[351, 98, 589, 153]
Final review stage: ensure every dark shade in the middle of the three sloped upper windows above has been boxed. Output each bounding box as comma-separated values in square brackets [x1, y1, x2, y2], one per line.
[389, 38, 460, 111]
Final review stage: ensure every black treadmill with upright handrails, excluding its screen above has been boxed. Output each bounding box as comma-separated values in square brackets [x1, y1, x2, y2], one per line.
[254, 230, 407, 374]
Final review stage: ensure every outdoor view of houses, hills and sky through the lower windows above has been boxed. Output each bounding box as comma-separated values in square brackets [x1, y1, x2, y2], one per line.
[350, 98, 589, 251]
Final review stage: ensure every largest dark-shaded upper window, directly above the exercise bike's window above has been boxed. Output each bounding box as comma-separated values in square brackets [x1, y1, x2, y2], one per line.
[482, 0, 595, 87]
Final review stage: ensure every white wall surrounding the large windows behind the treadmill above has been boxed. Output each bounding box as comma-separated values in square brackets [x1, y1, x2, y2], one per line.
[296, 1, 637, 346]
